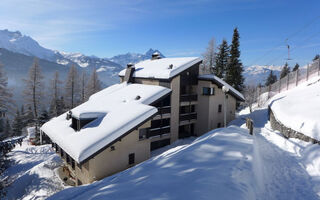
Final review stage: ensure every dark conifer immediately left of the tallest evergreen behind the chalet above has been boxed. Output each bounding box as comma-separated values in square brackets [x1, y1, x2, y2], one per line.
[214, 39, 230, 78]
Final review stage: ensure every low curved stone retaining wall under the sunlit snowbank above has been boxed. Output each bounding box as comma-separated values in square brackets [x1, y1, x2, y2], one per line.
[268, 107, 320, 144]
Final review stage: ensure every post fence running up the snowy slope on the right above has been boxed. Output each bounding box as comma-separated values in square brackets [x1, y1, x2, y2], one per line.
[257, 59, 320, 101]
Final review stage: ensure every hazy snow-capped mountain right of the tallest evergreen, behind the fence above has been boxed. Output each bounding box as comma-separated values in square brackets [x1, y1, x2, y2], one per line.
[243, 65, 283, 85]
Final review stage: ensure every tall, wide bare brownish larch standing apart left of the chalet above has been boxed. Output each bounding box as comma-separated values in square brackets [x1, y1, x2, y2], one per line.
[24, 58, 44, 120]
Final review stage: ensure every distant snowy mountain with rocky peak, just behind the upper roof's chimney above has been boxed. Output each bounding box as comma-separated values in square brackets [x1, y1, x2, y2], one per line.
[109, 48, 165, 67]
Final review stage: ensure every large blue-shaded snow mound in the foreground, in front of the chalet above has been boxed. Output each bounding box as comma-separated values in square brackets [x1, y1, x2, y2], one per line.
[49, 127, 256, 199]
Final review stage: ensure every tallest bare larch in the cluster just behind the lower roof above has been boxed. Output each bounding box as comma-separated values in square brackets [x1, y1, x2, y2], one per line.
[64, 65, 80, 109]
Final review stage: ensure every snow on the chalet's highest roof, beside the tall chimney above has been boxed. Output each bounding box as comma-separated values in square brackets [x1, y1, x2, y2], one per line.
[119, 57, 202, 79]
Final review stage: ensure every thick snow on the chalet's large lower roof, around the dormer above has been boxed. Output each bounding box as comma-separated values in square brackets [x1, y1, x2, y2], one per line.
[41, 82, 171, 163]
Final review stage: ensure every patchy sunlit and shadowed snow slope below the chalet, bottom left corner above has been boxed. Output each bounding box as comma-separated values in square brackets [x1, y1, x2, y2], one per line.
[3, 141, 65, 200]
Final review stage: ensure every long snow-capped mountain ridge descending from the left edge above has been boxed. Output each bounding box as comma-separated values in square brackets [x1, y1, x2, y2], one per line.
[0, 30, 123, 85]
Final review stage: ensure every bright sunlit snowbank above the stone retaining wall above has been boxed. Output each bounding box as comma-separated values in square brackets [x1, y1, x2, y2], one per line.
[269, 77, 320, 140]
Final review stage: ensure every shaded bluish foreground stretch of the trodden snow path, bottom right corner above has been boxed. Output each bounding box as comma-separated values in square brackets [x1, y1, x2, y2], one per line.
[253, 129, 318, 200]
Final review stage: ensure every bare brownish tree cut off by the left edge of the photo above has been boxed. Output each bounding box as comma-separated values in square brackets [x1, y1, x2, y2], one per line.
[0, 63, 13, 115]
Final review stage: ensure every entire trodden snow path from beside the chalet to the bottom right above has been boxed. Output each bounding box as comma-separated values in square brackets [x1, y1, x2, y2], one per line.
[233, 108, 319, 199]
